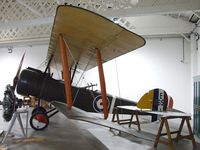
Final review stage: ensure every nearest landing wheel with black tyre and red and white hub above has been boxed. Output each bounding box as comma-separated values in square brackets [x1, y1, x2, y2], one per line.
[30, 111, 49, 131]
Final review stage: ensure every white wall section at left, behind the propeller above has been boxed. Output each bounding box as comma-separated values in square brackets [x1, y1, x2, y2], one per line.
[0, 45, 48, 101]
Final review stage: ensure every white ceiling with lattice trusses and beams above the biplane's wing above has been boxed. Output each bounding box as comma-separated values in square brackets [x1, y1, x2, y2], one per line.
[0, 0, 200, 47]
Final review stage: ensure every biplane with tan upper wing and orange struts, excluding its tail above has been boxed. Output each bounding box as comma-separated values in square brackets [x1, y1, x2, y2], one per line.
[1, 5, 145, 130]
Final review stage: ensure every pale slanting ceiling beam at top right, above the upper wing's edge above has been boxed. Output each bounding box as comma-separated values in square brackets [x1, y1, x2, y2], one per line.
[98, 0, 200, 17]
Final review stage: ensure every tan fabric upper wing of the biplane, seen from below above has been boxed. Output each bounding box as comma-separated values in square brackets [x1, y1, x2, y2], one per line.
[48, 6, 145, 70]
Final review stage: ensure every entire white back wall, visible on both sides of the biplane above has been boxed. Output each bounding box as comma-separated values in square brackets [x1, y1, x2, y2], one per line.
[0, 38, 193, 112]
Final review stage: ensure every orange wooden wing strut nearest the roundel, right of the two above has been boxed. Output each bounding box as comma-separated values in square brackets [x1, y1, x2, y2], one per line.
[96, 48, 108, 119]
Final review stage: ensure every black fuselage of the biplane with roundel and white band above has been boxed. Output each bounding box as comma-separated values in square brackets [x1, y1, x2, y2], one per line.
[17, 68, 136, 113]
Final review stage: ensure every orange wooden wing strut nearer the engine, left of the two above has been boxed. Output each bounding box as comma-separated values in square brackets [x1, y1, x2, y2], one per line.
[59, 34, 73, 109]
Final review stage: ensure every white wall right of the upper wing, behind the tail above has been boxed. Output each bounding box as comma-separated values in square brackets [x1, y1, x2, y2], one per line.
[83, 38, 193, 112]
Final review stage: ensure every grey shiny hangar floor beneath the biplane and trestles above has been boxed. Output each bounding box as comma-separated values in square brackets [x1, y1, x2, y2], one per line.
[0, 106, 200, 150]
